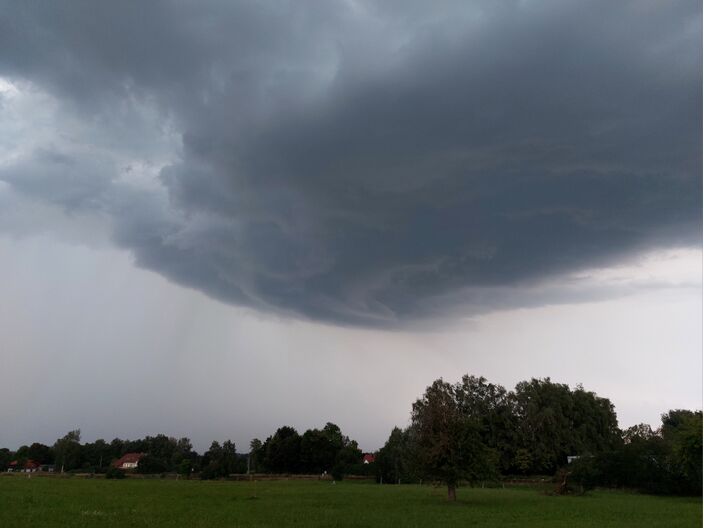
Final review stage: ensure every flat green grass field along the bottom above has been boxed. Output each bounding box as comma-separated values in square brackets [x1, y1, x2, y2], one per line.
[0, 477, 702, 528]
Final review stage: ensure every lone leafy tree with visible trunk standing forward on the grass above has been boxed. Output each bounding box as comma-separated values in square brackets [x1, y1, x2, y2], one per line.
[411, 379, 493, 500]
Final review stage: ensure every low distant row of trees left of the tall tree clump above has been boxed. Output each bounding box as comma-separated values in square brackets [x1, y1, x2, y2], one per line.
[0, 422, 369, 479]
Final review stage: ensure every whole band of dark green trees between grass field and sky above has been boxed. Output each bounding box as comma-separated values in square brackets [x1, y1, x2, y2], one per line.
[0, 375, 702, 494]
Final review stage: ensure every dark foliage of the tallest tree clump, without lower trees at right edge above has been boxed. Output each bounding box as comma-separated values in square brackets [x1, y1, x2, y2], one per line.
[376, 375, 628, 492]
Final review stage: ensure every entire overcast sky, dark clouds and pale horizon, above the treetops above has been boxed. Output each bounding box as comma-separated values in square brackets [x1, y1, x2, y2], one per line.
[0, 0, 702, 450]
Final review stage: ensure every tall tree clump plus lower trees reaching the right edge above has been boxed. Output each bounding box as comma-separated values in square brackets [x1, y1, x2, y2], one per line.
[376, 375, 702, 500]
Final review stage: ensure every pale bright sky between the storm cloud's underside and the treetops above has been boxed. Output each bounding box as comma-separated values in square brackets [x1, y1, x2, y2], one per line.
[0, 236, 702, 451]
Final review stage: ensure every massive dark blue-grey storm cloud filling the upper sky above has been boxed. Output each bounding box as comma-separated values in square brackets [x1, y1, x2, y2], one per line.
[0, 0, 702, 325]
